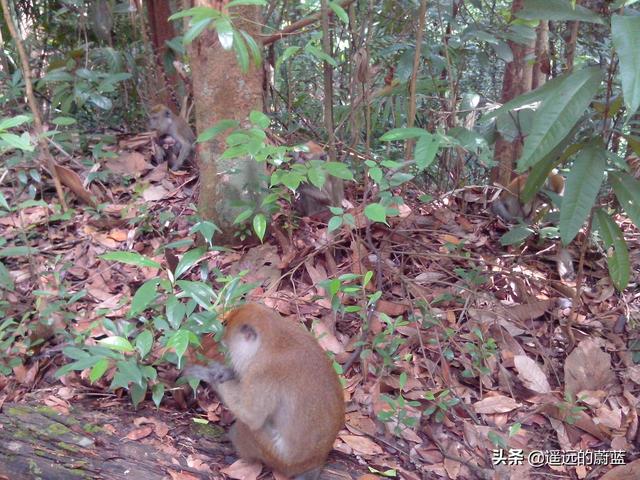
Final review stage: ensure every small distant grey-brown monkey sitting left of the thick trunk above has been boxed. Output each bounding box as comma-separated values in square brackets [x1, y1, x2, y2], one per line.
[149, 105, 196, 170]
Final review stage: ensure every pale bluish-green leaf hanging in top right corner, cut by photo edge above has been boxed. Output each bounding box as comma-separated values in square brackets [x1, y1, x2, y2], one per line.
[611, 15, 640, 117]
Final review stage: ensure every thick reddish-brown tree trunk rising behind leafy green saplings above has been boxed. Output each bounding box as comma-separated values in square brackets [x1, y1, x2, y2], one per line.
[190, 0, 263, 244]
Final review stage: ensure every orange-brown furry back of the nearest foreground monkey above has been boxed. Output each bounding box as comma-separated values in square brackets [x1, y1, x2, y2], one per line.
[230, 305, 344, 475]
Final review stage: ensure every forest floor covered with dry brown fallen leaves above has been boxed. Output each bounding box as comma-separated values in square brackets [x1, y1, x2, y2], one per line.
[0, 139, 640, 480]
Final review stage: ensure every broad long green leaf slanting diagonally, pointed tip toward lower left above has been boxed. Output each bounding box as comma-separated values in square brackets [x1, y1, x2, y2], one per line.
[518, 67, 602, 172]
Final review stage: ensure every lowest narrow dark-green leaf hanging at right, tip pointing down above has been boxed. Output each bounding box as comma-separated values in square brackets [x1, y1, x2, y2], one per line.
[595, 208, 631, 291]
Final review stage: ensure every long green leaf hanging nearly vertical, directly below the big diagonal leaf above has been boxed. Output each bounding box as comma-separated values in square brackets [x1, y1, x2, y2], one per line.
[560, 142, 607, 245]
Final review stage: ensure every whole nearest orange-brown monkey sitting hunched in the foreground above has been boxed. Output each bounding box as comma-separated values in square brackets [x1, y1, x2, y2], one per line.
[183, 304, 344, 480]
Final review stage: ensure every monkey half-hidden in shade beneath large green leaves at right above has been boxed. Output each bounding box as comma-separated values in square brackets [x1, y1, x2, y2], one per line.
[491, 173, 564, 222]
